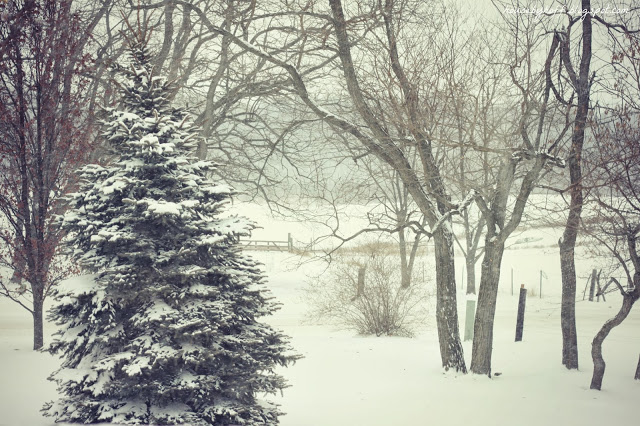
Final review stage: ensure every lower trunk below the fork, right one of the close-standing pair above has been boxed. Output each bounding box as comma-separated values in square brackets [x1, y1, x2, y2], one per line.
[471, 238, 504, 377]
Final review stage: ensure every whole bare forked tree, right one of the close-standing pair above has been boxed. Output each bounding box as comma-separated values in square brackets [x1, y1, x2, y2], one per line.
[471, 3, 570, 376]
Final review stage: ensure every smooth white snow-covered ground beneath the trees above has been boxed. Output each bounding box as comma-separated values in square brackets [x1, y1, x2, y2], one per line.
[0, 205, 640, 426]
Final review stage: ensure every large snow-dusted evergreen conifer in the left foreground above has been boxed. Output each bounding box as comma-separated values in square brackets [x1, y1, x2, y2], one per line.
[43, 28, 298, 425]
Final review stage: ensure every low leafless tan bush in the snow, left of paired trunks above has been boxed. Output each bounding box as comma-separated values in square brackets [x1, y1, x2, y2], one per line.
[306, 251, 429, 337]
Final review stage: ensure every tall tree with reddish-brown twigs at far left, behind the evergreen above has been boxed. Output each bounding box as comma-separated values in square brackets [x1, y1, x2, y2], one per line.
[0, 0, 95, 349]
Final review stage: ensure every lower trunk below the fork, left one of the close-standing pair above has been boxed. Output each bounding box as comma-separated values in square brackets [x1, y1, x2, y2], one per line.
[433, 224, 467, 373]
